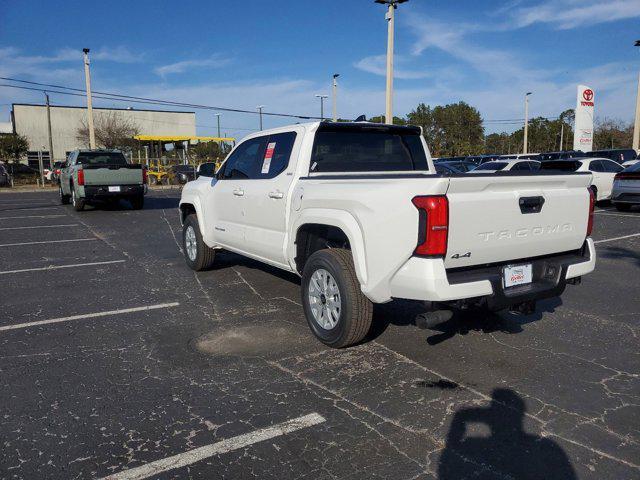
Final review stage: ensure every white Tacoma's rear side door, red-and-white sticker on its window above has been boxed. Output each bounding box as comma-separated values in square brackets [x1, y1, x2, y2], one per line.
[243, 131, 302, 266]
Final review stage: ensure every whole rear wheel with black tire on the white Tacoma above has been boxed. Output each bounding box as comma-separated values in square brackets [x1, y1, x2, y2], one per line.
[302, 248, 373, 348]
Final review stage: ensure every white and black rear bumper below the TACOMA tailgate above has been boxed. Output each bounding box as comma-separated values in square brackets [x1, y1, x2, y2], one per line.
[390, 238, 596, 309]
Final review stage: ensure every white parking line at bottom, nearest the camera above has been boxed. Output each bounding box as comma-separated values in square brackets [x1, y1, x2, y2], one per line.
[102, 413, 326, 480]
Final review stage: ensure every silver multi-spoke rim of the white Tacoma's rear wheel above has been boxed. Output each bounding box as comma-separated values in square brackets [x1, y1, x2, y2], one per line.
[308, 268, 342, 330]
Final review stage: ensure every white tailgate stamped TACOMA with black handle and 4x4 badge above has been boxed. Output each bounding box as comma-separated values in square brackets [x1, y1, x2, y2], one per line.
[445, 174, 591, 268]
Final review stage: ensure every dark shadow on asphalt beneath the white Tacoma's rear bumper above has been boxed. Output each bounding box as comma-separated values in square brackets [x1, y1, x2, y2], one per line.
[368, 297, 562, 345]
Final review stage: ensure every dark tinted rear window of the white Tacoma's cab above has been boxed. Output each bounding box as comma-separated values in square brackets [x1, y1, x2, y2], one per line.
[309, 127, 429, 173]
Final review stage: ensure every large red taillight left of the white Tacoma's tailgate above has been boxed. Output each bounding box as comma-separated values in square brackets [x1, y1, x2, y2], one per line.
[411, 195, 449, 256]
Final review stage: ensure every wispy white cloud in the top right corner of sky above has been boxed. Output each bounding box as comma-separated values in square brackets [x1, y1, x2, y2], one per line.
[505, 0, 640, 30]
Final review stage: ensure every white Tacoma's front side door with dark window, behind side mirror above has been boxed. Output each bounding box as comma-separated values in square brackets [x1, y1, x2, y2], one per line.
[205, 136, 268, 248]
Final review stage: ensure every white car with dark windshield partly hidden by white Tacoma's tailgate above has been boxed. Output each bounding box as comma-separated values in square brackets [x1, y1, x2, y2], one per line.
[541, 157, 624, 202]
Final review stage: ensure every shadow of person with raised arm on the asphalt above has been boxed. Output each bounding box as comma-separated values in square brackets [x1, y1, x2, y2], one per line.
[438, 389, 577, 480]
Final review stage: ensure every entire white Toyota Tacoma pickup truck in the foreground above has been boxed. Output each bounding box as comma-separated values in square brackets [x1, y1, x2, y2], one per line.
[180, 122, 596, 347]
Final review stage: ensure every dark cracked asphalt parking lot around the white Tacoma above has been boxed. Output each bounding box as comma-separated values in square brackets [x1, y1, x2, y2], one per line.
[0, 190, 640, 479]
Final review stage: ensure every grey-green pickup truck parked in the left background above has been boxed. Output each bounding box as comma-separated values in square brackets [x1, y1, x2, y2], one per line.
[60, 150, 147, 211]
